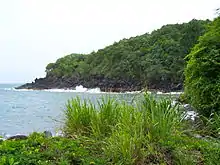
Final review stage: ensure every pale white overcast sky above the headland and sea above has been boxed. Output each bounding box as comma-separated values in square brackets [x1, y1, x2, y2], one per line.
[0, 0, 220, 83]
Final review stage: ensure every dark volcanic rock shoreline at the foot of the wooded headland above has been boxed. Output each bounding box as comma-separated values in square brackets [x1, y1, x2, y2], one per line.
[16, 76, 183, 92]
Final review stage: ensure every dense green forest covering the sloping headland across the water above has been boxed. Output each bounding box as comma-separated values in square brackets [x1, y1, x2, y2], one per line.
[43, 20, 210, 90]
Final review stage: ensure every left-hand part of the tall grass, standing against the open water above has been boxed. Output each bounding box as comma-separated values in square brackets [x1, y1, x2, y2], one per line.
[63, 98, 123, 138]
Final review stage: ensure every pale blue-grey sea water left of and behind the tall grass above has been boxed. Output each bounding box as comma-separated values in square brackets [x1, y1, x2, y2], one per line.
[0, 84, 133, 135]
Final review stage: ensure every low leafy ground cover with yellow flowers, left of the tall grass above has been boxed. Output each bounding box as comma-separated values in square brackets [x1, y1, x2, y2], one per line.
[0, 133, 105, 165]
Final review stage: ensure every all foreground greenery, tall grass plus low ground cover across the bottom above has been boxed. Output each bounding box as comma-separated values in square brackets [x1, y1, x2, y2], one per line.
[0, 95, 220, 165]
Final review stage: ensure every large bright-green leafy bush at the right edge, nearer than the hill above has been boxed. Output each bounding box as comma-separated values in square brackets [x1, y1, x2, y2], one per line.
[185, 17, 220, 117]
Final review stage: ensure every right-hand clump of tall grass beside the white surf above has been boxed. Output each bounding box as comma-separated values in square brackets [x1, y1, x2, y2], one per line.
[140, 95, 185, 141]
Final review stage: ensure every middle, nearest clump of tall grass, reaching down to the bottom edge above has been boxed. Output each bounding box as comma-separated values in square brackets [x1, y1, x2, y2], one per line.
[104, 106, 147, 164]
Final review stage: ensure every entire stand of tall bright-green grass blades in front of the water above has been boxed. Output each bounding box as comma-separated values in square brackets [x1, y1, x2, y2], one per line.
[64, 94, 184, 164]
